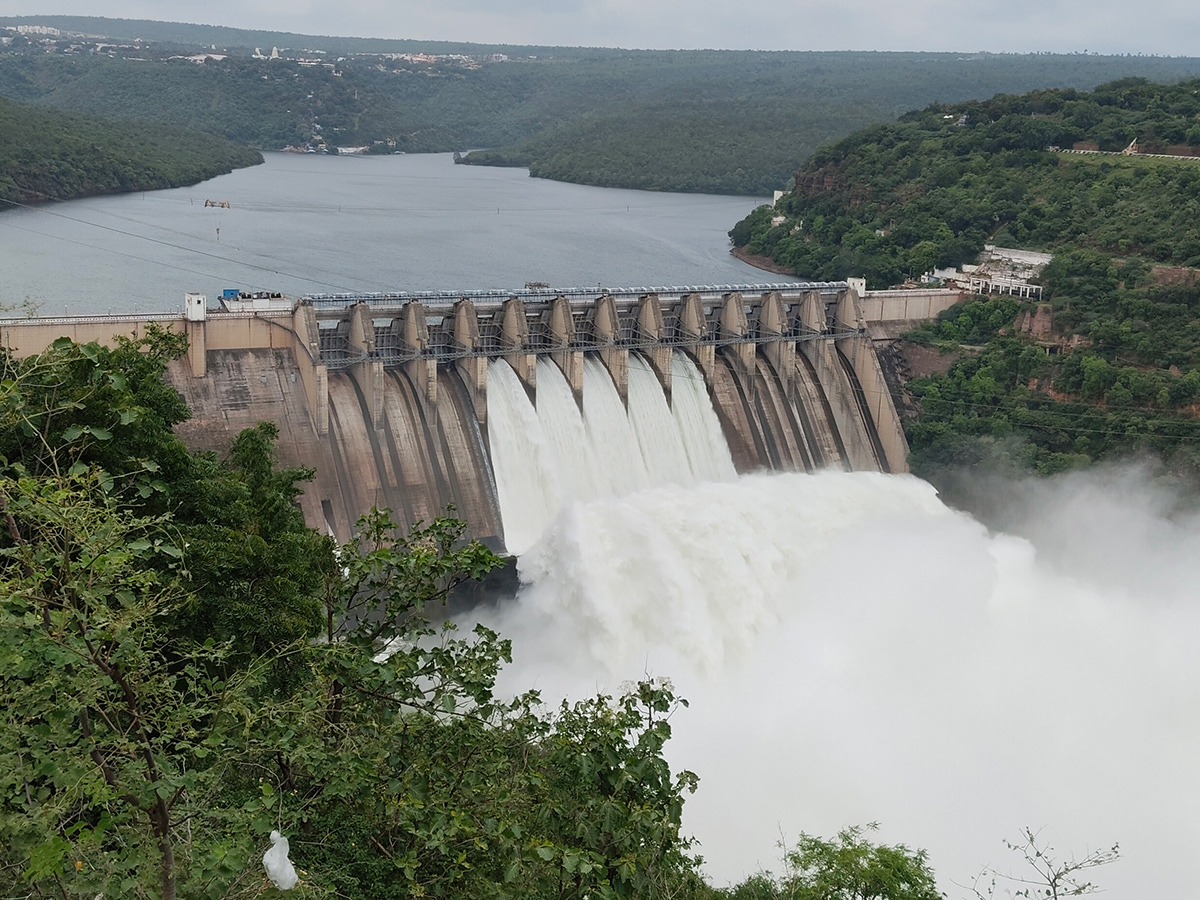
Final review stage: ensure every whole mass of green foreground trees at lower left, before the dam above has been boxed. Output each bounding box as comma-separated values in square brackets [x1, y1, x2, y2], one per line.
[0, 344, 702, 900]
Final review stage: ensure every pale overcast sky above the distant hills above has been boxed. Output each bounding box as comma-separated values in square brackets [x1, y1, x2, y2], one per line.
[0, 0, 1200, 56]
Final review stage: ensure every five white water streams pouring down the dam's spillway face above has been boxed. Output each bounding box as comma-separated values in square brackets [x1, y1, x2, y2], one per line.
[487, 354, 734, 553]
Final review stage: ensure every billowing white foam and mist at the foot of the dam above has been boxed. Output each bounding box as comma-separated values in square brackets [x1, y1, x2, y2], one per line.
[472, 473, 1200, 900]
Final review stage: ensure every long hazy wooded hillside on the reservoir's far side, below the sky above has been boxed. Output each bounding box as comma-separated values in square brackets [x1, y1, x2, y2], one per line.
[7, 17, 1200, 196]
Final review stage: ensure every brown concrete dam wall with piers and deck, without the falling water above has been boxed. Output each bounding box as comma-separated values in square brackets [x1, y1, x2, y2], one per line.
[0, 282, 960, 546]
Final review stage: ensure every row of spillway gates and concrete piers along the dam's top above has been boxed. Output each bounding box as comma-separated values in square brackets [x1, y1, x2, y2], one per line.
[302, 282, 857, 370]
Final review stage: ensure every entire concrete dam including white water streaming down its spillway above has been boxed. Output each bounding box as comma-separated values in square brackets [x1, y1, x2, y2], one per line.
[0, 280, 960, 552]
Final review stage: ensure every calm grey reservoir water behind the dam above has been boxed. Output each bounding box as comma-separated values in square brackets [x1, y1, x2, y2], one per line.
[0, 154, 785, 314]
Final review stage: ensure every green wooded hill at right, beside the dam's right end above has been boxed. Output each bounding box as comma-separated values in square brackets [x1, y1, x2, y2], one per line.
[731, 79, 1200, 487]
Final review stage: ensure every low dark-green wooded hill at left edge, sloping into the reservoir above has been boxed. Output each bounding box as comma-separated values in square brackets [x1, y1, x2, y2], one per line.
[0, 97, 263, 211]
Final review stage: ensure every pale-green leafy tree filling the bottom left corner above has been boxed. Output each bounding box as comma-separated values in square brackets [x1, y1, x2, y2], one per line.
[0, 469, 291, 900]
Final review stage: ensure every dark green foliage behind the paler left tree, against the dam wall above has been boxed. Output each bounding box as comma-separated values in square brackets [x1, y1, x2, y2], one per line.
[0, 336, 334, 674]
